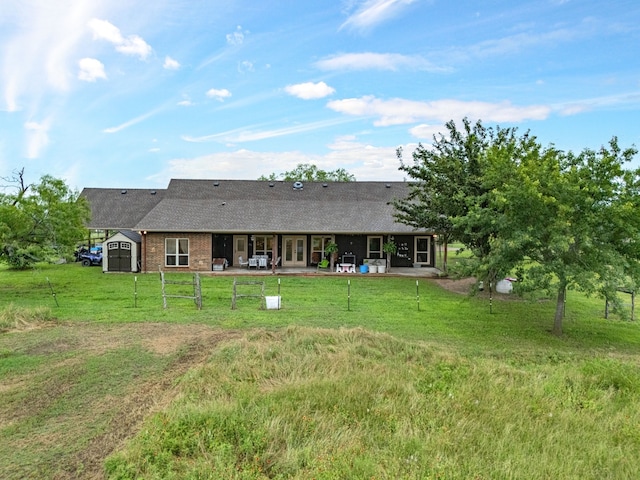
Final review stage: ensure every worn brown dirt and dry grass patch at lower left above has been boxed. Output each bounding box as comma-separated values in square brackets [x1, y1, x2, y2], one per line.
[0, 323, 239, 479]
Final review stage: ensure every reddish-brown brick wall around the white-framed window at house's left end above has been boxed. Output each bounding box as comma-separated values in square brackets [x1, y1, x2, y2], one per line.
[142, 233, 212, 272]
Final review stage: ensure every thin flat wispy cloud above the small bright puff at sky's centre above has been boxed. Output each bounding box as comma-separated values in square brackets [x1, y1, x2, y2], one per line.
[315, 52, 451, 72]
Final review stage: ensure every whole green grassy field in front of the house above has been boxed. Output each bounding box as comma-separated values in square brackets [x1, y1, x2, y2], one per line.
[0, 265, 640, 479]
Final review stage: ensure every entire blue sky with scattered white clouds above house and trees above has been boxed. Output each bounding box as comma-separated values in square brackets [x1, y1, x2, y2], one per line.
[0, 0, 640, 189]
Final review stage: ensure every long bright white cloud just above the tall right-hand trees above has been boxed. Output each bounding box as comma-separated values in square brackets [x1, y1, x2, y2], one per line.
[327, 96, 551, 126]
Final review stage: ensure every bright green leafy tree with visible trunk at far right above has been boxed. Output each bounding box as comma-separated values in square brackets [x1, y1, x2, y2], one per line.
[480, 138, 640, 335]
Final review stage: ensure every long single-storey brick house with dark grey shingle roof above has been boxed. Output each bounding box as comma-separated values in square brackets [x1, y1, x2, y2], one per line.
[82, 179, 435, 272]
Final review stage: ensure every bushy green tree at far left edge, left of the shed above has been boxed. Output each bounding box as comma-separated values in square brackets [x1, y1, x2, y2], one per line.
[0, 169, 90, 268]
